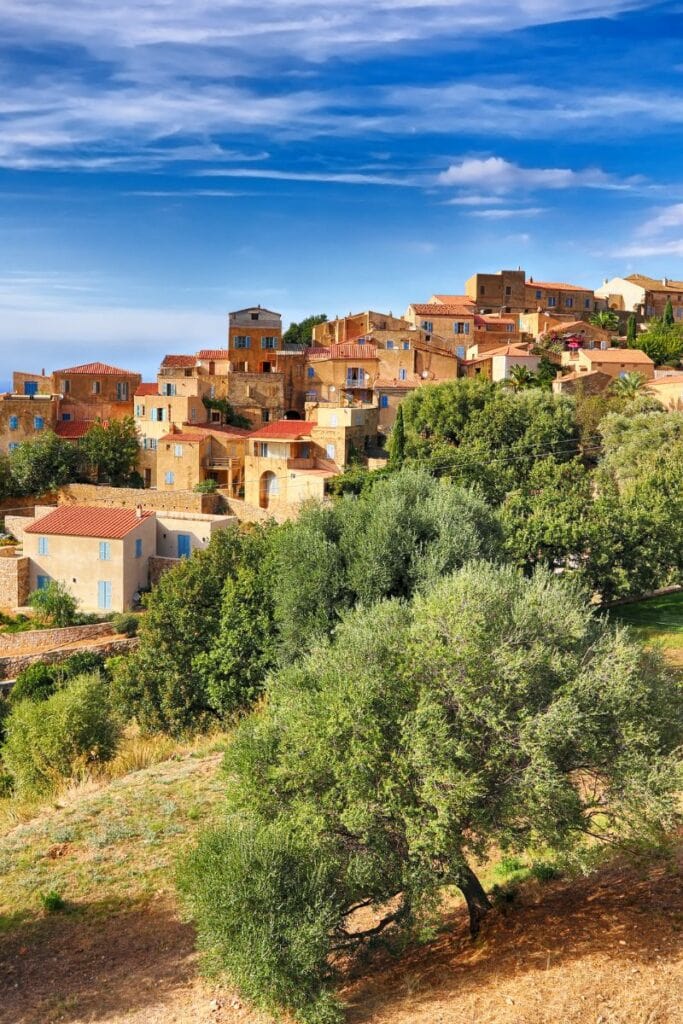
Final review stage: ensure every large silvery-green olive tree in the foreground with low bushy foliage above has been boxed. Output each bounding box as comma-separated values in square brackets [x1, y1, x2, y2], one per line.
[180, 563, 683, 1024]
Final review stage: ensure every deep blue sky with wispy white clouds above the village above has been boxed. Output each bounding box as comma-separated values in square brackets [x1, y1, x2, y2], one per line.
[0, 0, 683, 381]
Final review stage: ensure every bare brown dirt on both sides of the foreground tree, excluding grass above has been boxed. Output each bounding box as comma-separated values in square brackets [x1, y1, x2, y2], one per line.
[0, 847, 683, 1024]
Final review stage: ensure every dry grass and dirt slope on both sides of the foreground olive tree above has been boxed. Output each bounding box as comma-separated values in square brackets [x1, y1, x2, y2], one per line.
[0, 753, 683, 1024]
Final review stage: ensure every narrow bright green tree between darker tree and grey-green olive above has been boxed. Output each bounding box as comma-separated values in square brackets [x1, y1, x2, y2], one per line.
[193, 527, 278, 718]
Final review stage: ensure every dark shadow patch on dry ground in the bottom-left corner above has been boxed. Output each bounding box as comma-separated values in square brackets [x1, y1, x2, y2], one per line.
[0, 902, 197, 1024]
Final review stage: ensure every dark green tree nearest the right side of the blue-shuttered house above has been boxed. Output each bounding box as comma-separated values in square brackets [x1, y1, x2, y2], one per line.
[112, 527, 248, 735]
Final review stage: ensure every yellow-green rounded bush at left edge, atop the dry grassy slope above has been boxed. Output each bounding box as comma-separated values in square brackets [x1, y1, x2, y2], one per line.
[2, 675, 120, 796]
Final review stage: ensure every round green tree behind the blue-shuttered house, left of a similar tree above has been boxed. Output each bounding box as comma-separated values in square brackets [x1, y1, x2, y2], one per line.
[9, 430, 82, 497]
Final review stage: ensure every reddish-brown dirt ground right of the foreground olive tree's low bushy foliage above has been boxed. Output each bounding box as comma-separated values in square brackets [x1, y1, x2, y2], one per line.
[341, 851, 683, 1024]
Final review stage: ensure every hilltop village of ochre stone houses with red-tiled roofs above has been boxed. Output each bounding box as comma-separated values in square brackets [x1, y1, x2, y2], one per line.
[0, 268, 683, 611]
